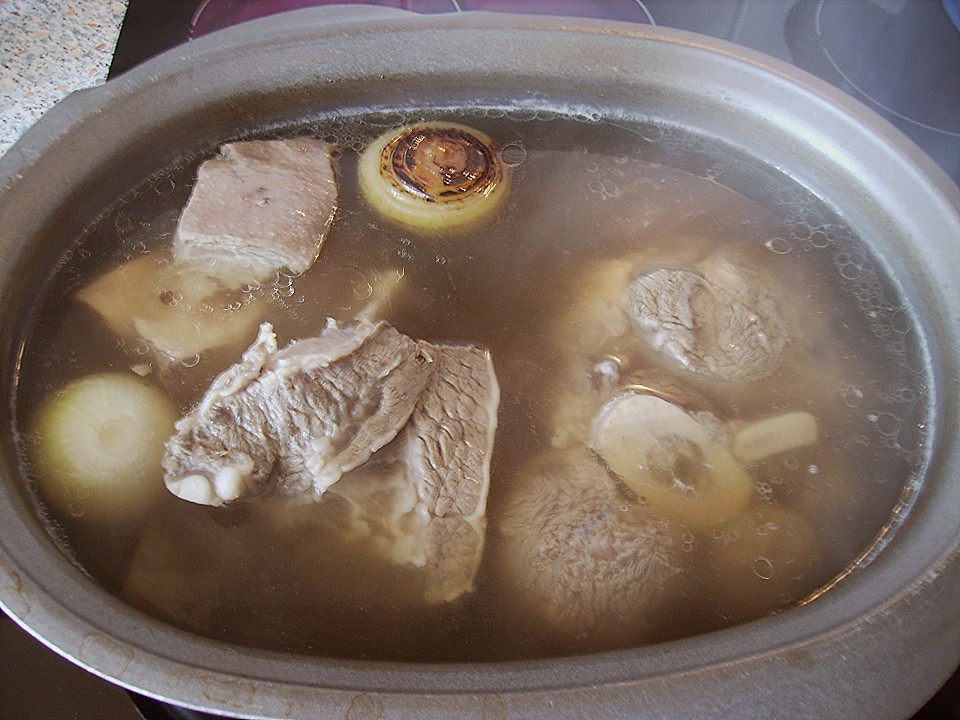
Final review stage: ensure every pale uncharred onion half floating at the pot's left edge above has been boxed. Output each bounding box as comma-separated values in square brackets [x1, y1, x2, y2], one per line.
[30, 373, 178, 521]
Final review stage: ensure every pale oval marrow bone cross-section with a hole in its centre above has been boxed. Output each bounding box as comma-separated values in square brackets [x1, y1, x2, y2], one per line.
[591, 392, 753, 531]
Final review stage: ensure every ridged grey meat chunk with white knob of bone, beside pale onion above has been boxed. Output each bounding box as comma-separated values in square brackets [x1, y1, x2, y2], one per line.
[163, 321, 432, 505]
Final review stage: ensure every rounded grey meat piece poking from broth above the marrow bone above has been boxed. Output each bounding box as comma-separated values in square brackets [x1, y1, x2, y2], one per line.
[626, 259, 787, 380]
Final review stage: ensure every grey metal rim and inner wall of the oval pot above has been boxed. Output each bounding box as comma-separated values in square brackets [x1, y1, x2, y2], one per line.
[0, 8, 960, 720]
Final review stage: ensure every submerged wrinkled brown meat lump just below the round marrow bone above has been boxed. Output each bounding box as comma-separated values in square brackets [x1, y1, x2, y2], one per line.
[499, 450, 681, 645]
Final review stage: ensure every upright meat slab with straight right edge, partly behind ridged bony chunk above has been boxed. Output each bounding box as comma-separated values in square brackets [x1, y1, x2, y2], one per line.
[331, 343, 500, 602]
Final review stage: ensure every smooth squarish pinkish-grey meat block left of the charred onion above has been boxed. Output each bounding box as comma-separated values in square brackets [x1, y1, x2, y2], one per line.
[173, 138, 337, 288]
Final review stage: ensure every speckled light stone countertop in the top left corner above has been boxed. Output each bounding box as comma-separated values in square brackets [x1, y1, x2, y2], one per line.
[0, 0, 127, 155]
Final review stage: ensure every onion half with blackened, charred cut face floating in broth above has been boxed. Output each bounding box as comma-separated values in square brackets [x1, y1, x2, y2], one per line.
[359, 123, 508, 231]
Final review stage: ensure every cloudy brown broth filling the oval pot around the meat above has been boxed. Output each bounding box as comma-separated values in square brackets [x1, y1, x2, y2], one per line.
[17, 111, 928, 662]
